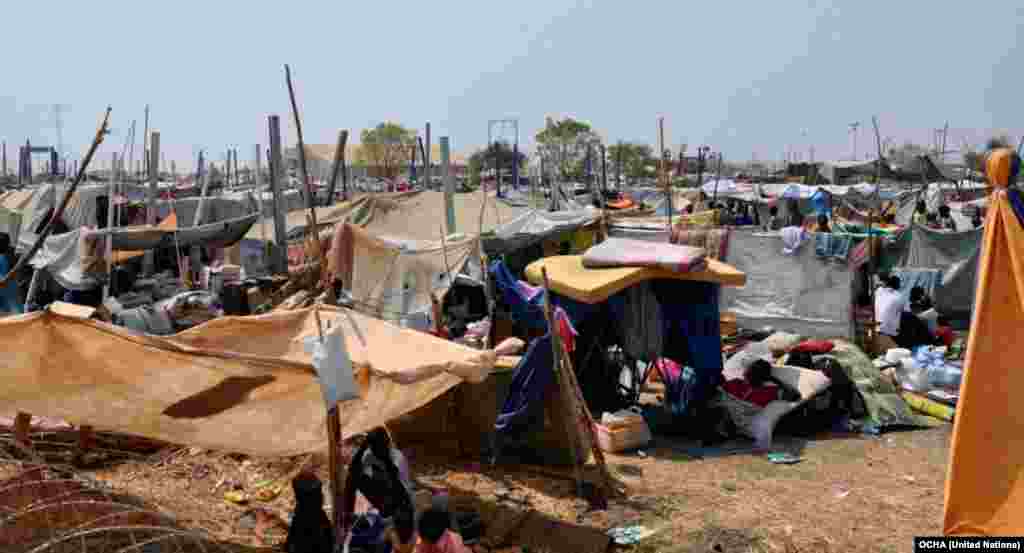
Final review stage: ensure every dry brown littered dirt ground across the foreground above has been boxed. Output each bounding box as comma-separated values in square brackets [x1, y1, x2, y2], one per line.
[0, 426, 951, 553]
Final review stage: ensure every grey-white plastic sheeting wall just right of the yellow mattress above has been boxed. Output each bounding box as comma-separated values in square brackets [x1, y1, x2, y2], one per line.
[721, 229, 853, 338]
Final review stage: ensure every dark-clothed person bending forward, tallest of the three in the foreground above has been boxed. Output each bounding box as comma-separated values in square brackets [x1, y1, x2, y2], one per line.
[342, 428, 416, 544]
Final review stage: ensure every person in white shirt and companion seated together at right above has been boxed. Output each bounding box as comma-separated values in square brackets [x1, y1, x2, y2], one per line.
[874, 274, 953, 352]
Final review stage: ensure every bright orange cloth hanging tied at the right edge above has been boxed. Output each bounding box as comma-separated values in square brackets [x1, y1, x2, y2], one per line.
[943, 185, 1024, 536]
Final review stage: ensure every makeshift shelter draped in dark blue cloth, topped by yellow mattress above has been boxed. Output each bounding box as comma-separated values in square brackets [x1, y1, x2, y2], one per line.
[516, 252, 745, 415]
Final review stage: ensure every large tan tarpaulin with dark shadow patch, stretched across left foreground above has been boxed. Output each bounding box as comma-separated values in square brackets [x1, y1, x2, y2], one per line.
[0, 307, 496, 456]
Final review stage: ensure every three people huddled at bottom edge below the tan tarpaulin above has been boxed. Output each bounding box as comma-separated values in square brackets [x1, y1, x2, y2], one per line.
[285, 428, 473, 553]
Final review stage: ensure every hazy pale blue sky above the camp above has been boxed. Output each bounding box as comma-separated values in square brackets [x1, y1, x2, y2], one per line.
[0, 0, 1024, 168]
